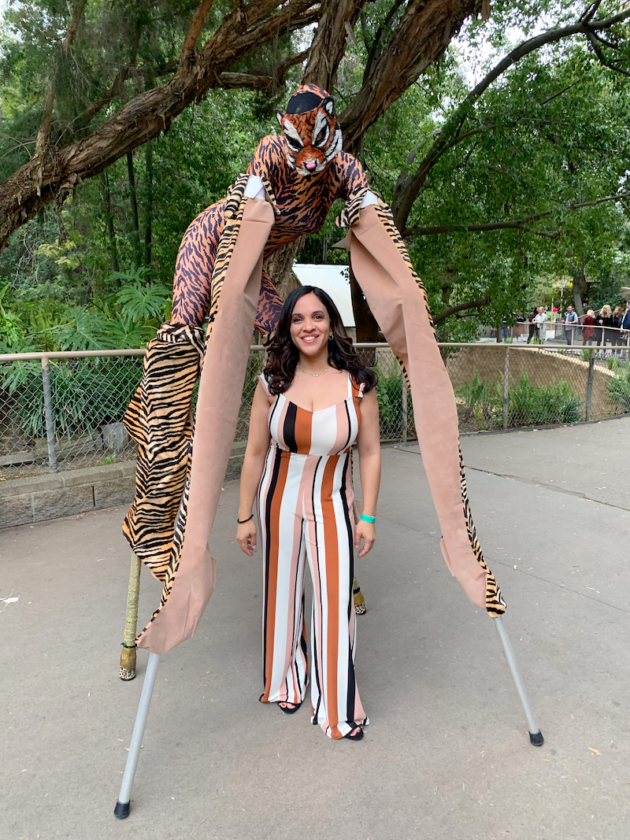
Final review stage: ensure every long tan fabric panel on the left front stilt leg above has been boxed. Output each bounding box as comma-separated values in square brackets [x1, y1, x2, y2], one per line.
[138, 199, 274, 653]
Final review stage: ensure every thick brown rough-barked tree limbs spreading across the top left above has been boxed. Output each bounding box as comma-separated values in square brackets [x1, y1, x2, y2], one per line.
[0, 0, 494, 247]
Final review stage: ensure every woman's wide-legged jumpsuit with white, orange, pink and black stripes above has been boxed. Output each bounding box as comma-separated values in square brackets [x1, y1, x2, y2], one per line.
[258, 374, 368, 739]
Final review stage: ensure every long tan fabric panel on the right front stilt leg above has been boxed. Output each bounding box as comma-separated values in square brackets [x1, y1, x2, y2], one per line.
[350, 206, 505, 614]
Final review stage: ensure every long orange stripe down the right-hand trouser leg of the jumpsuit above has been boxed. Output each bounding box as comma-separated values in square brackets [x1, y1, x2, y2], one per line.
[321, 456, 342, 739]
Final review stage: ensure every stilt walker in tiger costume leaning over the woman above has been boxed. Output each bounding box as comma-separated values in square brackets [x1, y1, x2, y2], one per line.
[117, 85, 542, 816]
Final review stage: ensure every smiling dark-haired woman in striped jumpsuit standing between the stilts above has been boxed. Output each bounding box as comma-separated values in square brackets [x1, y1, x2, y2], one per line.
[236, 286, 381, 741]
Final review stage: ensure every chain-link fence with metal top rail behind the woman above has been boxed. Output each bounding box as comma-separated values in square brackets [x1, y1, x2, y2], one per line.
[0, 343, 630, 480]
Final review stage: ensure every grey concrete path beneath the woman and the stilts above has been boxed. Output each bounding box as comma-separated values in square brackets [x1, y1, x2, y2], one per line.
[0, 419, 630, 840]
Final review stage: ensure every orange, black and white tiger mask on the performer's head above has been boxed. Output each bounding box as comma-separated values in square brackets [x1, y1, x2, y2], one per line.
[276, 85, 342, 175]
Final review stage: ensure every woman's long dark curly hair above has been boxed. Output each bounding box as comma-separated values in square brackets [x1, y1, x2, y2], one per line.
[263, 286, 377, 394]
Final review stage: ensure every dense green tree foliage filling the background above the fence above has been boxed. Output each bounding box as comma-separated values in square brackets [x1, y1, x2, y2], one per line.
[0, 0, 630, 350]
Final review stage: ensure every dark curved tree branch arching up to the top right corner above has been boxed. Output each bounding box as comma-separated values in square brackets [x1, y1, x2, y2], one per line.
[392, 9, 630, 230]
